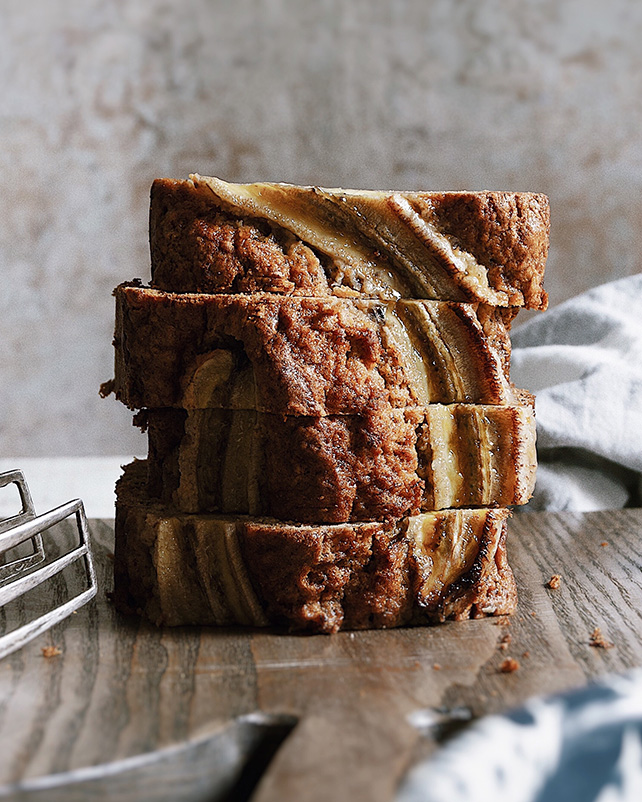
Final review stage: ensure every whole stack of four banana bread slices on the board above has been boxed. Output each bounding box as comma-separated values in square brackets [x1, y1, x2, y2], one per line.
[104, 175, 549, 632]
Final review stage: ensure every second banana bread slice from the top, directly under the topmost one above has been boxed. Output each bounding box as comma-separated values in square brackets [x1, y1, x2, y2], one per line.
[106, 285, 522, 416]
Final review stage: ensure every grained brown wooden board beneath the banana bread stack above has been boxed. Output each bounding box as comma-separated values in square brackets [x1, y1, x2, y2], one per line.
[0, 510, 642, 802]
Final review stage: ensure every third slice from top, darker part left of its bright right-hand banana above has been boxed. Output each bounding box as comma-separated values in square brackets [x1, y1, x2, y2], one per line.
[148, 409, 424, 523]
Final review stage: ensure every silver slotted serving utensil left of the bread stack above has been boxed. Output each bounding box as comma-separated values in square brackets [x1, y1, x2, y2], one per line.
[0, 470, 97, 659]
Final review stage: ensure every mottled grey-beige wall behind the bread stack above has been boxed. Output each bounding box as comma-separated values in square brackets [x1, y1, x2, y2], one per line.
[0, 0, 642, 456]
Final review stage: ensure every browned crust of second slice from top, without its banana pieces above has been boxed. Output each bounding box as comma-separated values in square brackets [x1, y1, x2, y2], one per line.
[115, 286, 404, 415]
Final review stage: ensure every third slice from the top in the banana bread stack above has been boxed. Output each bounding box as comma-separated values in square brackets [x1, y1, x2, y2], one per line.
[144, 404, 536, 523]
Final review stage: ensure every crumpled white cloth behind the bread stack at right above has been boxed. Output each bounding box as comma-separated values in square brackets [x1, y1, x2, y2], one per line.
[511, 275, 642, 512]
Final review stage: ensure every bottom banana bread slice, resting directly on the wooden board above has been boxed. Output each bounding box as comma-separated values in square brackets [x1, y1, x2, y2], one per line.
[114, 461, 517, 633]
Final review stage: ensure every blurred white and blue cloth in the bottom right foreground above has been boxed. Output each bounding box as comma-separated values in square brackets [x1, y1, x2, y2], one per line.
[396, 669, 642, 802]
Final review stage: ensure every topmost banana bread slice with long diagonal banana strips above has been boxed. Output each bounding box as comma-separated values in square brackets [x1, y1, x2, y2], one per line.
[150, 175, 549, 309]
